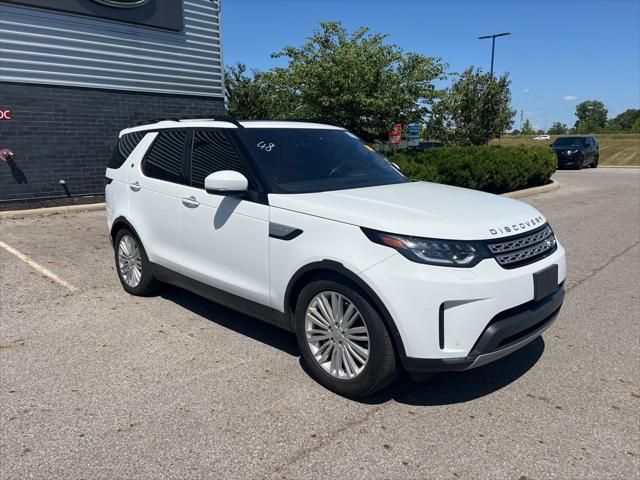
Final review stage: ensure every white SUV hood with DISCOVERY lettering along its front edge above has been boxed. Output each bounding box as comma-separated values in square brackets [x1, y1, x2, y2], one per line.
[269, 182, 546, 240]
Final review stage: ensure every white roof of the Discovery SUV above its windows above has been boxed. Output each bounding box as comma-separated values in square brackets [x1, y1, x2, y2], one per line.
[120, 118, 344, 136]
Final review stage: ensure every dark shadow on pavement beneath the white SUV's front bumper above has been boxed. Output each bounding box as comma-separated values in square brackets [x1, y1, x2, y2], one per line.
[360, 337, 545, 406]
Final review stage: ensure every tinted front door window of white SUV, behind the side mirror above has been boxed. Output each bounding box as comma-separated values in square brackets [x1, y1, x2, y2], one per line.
[191, 129, 251, 188]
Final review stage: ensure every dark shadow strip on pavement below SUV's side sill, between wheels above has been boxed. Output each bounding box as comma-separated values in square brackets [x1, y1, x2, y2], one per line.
[158, 285, 300, 357]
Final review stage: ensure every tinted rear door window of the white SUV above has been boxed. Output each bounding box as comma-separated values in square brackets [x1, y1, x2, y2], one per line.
[142, 130, 188, 185]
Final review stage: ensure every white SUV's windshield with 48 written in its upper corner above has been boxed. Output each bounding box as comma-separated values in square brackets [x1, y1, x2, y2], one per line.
[234, 128, 408, 193]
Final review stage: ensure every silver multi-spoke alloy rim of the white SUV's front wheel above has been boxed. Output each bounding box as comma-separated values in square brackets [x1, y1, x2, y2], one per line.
[305, 291, 370, 380]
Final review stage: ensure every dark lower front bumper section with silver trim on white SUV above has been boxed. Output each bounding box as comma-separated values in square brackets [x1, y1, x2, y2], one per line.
[401, 286, 565, 373]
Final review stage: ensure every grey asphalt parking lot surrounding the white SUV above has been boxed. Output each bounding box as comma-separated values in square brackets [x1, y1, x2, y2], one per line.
[0, 169, 640, 480]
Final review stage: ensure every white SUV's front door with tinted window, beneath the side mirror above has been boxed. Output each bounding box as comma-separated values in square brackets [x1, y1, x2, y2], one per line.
[181, 128, 270, 306]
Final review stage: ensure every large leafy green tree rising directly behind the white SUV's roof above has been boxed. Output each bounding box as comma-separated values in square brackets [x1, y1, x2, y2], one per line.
[264, 22, 446, 140]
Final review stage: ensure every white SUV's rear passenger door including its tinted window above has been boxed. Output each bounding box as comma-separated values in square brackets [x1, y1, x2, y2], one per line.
[129, 129, 189, 273]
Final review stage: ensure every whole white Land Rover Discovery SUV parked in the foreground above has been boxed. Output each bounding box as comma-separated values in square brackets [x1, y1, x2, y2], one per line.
[106, 117, 566, 397]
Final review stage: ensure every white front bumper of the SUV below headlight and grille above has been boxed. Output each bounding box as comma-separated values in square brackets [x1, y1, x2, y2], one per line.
[359, 243, 566, 362]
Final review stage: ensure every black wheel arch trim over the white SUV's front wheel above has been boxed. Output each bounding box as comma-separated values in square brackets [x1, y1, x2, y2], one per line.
[284, 260, 406, 357]
